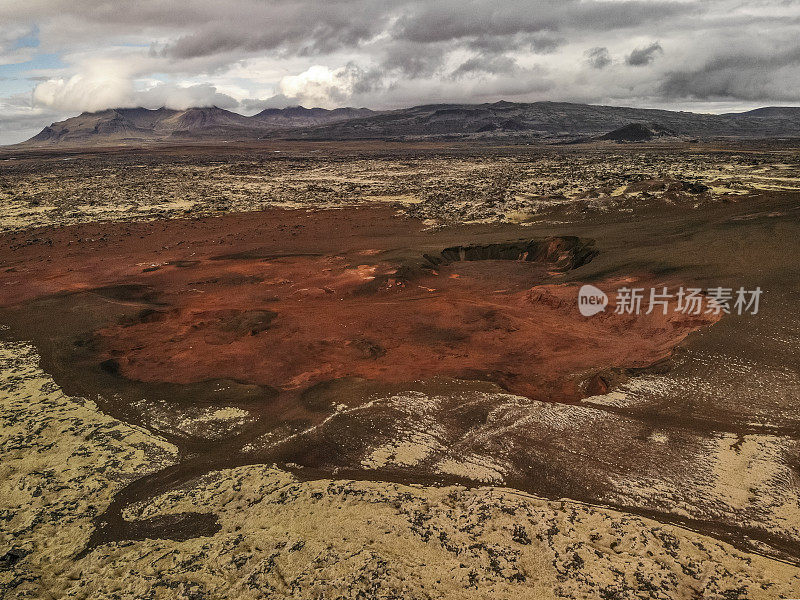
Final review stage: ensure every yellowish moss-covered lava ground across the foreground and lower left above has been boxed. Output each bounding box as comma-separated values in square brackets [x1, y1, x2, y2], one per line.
[0, 343, 800, 600]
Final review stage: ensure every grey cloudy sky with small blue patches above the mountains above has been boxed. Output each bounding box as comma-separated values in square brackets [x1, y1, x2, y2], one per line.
[0, 0, 800, 143]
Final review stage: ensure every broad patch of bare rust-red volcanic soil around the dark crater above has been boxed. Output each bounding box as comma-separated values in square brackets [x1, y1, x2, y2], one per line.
[0, 208, 716, 402]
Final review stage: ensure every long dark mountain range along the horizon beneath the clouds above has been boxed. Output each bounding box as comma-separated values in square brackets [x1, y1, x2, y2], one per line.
[15, 101, 800, 147]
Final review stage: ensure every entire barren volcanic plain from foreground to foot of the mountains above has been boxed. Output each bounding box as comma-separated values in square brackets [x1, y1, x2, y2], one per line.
[0, 142, 800, 600]
